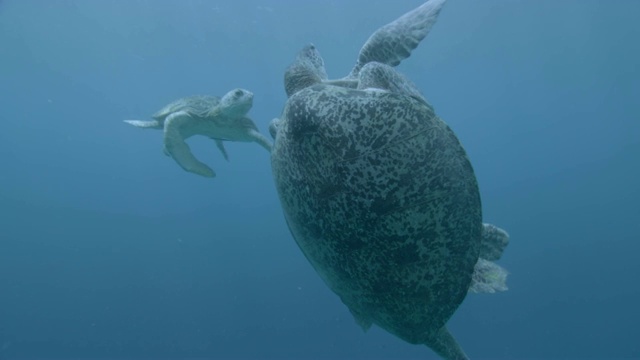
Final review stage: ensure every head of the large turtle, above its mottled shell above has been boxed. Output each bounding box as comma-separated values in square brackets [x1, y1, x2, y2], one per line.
[284, 44, 327, 97]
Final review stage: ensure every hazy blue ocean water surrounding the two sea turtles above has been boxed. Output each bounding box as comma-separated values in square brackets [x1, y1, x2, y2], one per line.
[0, 0, 640, 359]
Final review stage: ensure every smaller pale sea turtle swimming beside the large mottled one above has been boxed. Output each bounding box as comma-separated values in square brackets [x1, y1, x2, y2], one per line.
[124, 89, 272, 177]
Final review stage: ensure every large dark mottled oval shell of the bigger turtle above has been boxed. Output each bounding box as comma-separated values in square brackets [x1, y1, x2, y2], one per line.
[271, 85, 482, 343]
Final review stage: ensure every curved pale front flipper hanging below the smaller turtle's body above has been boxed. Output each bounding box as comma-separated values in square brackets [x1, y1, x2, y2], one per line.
[164, 111, 216, 177]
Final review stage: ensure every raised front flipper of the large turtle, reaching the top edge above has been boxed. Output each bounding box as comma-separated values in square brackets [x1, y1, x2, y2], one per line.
[349, 0, 446, 77]
